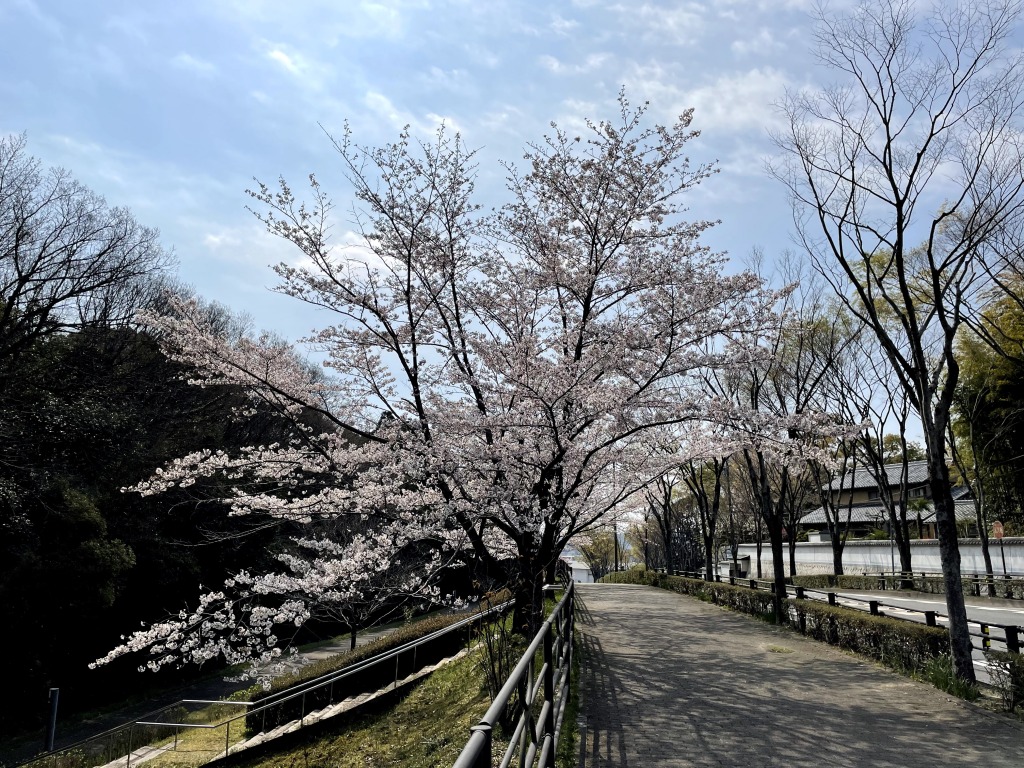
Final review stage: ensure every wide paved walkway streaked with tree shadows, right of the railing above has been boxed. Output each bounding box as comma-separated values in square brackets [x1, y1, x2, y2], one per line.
[578, 584, 1024, 768]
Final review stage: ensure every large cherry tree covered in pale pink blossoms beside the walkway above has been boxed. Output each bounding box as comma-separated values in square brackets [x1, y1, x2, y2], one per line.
[97, 96, 777, 664]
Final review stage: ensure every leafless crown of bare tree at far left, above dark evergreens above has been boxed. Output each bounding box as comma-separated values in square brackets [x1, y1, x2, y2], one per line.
[0, 135, 172, 387]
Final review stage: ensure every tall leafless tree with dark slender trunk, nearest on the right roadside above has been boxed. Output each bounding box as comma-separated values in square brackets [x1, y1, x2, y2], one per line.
[770, 0, 1024, 681]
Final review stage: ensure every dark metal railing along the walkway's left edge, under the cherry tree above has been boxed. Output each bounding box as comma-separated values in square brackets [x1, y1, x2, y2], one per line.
[454, 582, 575, 768]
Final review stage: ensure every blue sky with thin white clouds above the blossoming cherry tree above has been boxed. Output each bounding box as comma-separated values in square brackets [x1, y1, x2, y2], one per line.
[0, 0, 831, 339]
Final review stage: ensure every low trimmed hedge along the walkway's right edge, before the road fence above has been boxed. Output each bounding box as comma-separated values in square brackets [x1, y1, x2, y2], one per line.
[601, 569, 949, 674]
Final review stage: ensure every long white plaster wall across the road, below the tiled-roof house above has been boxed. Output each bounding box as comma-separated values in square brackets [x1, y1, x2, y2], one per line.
[739, 537, 1024, 575]
